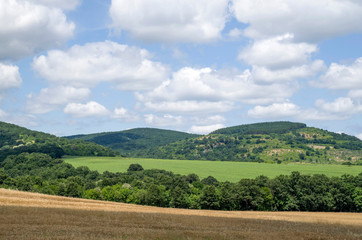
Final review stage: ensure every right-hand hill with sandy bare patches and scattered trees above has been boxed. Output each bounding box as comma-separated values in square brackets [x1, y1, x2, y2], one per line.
[143, 122, 362, 164]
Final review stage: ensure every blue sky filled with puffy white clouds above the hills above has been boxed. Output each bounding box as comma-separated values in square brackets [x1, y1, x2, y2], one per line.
[0, 0, 362, 139]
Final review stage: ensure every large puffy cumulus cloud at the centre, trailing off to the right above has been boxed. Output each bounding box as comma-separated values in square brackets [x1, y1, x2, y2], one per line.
[137, 68, 296, 114]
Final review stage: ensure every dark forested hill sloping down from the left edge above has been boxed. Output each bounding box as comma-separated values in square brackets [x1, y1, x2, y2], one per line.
[0, 122, 116, 162]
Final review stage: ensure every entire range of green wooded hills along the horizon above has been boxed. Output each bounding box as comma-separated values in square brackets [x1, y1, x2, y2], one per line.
[0, 122, 362, 165]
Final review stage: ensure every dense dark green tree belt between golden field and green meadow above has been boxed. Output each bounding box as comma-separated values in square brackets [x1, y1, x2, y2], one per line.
[0, 153, 362, 212]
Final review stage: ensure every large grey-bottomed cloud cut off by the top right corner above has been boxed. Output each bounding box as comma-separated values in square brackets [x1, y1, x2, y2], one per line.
[232, 0, 362, 42]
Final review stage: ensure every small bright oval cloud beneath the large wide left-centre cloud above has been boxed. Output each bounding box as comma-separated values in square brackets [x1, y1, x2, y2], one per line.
[64, 101, 110, 118]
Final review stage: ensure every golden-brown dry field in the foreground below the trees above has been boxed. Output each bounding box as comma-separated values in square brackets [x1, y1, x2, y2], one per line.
[0, 189, 362, 240]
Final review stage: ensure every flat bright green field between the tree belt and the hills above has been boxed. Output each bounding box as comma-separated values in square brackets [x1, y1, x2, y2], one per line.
[64, 157, 362, 182]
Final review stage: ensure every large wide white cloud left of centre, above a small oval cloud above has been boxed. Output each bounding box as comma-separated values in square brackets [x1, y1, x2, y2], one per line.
[33, 41, 168, 91]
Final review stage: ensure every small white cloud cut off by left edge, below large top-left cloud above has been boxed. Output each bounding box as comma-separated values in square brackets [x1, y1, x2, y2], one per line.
[0, 63, 22, 92]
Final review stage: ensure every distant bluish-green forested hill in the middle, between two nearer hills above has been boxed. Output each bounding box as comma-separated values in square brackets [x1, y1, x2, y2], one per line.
[66, 128, 201, 156]
